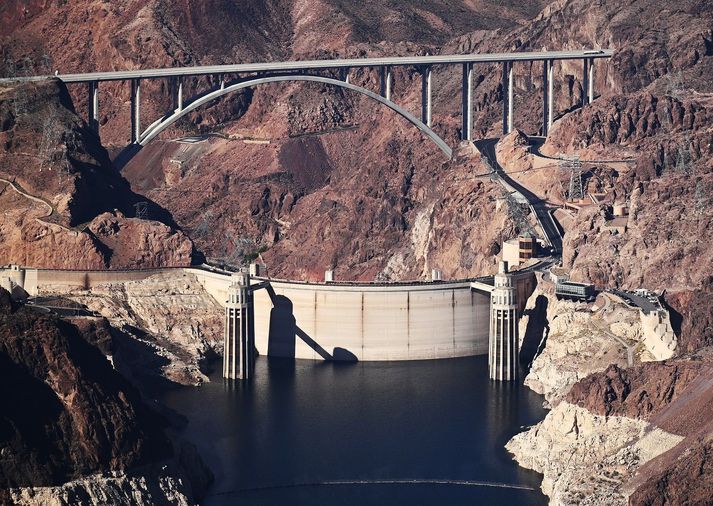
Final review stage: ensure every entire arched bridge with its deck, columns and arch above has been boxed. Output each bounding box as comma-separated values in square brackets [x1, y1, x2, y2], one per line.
[0, 50, 613, 164]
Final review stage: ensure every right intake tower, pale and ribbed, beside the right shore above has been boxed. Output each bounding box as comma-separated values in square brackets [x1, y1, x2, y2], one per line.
[488, 262, 520, 381]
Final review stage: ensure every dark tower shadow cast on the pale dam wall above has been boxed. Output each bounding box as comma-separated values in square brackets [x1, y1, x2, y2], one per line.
[267, 295, 358, 363]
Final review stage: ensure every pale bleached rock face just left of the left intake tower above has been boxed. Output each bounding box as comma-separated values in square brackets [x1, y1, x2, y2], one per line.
[65, 272, 223, 385]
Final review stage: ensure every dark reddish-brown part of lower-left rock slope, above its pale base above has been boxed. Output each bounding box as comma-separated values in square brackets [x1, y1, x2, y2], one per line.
[0, 288, 172, 488]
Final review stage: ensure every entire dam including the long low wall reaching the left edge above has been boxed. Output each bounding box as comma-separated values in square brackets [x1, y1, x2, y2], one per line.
[0, 266, 535, 368]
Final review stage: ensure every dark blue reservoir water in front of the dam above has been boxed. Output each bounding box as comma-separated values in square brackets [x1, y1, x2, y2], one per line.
[161, 357, 546, 506]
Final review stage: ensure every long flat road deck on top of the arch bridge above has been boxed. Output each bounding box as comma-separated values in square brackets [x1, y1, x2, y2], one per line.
[0, 49, 613, 83]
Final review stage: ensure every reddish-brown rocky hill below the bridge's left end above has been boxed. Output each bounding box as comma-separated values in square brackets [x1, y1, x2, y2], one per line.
[0, 80, 193, 269]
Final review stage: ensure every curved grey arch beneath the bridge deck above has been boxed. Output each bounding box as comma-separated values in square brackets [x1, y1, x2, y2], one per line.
[136, 75, 453, 159]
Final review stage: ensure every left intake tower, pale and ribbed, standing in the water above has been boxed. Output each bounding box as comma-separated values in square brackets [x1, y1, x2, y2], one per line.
[223, 269, 255, 380]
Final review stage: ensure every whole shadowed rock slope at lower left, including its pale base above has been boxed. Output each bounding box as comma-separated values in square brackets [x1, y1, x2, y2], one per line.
[0, 289, 212, 506]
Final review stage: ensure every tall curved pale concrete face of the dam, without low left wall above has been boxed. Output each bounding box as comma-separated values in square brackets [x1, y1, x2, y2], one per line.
[186, 269, 490, 361]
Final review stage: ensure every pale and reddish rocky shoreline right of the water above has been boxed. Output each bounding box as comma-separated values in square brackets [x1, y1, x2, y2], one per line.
[506, 279, 713, 506]
